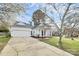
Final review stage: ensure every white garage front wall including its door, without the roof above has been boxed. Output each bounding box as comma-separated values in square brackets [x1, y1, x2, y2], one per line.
[10, 27, 31, 37]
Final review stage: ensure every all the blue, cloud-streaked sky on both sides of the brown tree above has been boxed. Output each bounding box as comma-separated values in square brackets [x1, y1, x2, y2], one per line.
[18, 3, 77, 23]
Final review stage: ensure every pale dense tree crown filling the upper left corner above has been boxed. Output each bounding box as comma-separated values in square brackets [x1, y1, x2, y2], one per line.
[0, 3, 24, 28]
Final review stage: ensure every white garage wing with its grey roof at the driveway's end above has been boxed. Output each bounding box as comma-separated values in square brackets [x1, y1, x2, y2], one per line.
[10, 22, 31, 37]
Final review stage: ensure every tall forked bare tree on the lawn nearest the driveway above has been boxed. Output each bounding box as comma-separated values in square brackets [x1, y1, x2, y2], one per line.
[42, 3, 72, 48]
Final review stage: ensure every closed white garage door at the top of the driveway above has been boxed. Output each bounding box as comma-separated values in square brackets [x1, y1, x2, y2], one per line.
[11, 31, 31, 37]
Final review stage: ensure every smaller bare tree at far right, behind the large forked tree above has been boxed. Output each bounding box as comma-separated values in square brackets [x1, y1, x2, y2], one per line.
[64, 9, 79, 40]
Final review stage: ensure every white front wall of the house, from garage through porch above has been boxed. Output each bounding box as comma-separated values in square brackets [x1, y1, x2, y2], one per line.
[10, 27, 58, 37]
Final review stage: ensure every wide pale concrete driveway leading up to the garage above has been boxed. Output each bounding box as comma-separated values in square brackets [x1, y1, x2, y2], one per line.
[0, 37, 73, 56]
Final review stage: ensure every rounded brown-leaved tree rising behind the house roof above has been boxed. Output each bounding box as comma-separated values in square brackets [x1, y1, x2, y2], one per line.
[32, 9, 45, 26]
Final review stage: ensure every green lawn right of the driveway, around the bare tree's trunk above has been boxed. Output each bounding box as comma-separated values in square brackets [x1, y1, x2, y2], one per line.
[41, 37, 79, 56]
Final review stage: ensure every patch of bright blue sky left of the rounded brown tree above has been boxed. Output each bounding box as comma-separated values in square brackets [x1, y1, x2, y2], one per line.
[18, 3, 39, 23]
